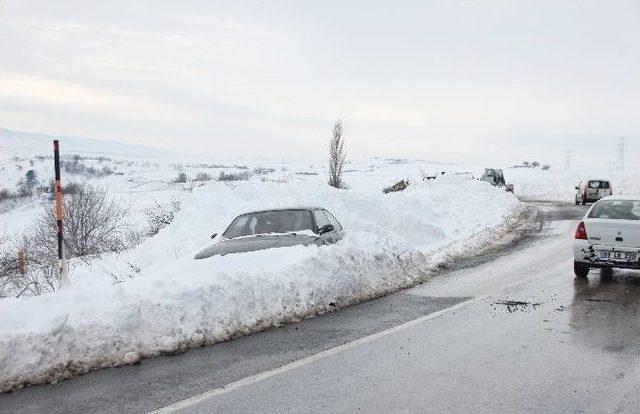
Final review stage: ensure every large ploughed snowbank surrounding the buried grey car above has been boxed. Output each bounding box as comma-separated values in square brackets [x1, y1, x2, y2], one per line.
[0, 176, 523, 391]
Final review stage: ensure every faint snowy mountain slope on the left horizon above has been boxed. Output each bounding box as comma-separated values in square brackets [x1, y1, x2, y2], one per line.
[0, 128, 171, 157]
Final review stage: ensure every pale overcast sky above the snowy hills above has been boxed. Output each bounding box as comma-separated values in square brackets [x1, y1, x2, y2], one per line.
[0, 0, 640, 163]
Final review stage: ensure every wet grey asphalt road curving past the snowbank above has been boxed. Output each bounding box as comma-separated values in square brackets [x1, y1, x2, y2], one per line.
[0, 205, 640, 413]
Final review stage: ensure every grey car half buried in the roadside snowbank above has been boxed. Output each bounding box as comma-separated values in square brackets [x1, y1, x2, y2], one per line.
[195, 207, 343, 259]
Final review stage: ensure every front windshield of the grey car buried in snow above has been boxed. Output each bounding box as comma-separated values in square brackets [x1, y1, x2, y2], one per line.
[223, 210, 313, 239]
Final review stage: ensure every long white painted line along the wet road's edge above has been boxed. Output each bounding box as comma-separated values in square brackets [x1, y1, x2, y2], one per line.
[148, 264, 562, 414]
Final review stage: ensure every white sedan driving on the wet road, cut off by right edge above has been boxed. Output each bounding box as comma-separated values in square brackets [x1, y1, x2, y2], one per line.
[573, 195, 640, 278]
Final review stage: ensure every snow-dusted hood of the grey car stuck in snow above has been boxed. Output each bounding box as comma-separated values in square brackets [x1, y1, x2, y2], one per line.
[195, 234, 318, 259]
